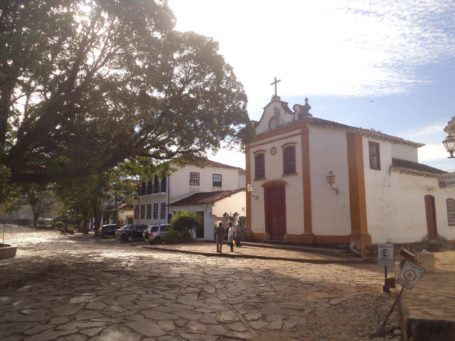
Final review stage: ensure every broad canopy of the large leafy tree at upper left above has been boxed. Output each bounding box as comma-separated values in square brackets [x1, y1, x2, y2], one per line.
[0, 0, 251, 193]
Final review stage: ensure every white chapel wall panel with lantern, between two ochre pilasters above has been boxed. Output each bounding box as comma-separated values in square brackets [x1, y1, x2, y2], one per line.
[309, 127, 351, 236]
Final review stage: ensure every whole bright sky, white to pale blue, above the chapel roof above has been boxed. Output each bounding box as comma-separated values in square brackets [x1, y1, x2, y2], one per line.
[168, 0, 455, 171]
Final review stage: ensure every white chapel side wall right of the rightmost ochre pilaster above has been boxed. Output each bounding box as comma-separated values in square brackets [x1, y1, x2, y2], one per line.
[363, 138, 455, 244]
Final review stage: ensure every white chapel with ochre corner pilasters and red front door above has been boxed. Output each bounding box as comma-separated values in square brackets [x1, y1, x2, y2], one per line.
[246, 96, 455, 252]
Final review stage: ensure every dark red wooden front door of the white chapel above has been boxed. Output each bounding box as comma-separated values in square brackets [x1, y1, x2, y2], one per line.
[264, 186, 286, 240]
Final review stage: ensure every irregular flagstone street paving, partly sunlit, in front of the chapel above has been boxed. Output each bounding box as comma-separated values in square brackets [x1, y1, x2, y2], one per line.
[0, 227, 400, 341]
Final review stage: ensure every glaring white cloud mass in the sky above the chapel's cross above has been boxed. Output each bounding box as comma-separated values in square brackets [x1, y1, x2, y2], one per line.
[169, 0, 455, 111]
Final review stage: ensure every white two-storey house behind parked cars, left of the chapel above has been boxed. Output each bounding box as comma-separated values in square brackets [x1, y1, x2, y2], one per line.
[134, 160, 246, 239]
